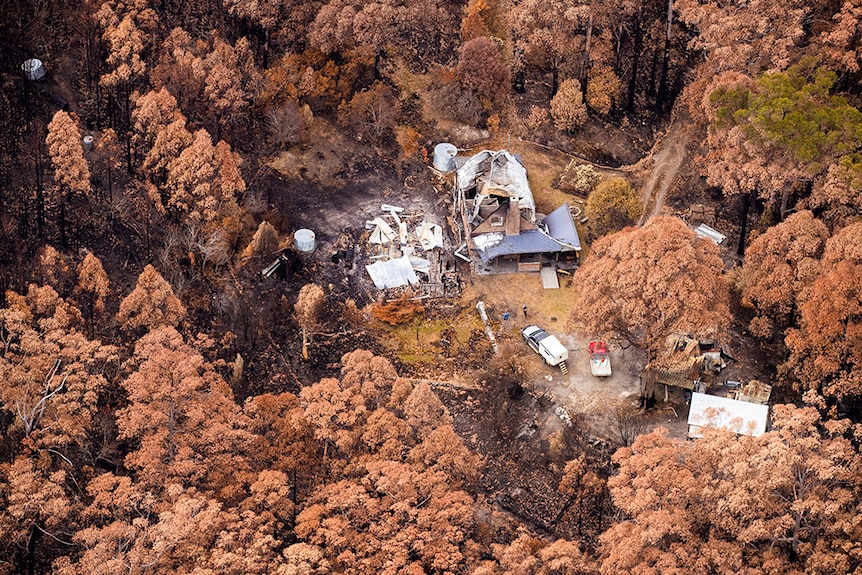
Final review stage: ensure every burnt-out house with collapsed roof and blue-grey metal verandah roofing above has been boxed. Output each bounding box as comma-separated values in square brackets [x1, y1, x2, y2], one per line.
[455, 150, 581, 273]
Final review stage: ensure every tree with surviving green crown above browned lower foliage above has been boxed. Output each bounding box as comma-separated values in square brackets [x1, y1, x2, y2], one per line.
[707, 60, 862, 199]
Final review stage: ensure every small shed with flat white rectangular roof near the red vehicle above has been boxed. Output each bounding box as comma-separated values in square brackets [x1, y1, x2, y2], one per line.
[688, 393, 769, 439]
